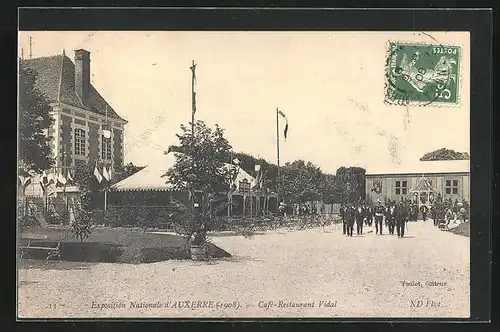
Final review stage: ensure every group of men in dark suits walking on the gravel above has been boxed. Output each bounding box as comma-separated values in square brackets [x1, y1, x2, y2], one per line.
[340, 200, 422, 237]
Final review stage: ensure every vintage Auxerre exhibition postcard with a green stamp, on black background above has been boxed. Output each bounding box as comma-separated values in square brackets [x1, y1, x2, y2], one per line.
[17, 31, 470, 319]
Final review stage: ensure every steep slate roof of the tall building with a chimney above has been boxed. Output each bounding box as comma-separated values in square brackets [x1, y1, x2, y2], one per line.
[21, 54, 126, 121]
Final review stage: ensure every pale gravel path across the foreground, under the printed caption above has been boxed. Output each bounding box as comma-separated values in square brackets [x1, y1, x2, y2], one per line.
[18, 221, 470, 318]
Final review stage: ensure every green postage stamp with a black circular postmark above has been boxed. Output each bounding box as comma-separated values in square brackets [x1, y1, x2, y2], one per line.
[385, 42, 462, 106]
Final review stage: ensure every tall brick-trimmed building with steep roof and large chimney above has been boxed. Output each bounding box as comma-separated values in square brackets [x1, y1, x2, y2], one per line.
[20, 49, 127, 185]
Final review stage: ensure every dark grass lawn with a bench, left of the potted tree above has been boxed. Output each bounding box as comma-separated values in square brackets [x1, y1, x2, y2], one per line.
[19, 227, 231, 264]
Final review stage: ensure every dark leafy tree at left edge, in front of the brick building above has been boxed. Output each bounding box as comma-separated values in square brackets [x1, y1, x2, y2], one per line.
[19, 63, 54, 172]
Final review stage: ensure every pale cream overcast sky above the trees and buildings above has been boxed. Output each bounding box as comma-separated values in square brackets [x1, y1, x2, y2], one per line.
[19, 32, 470, 173]
